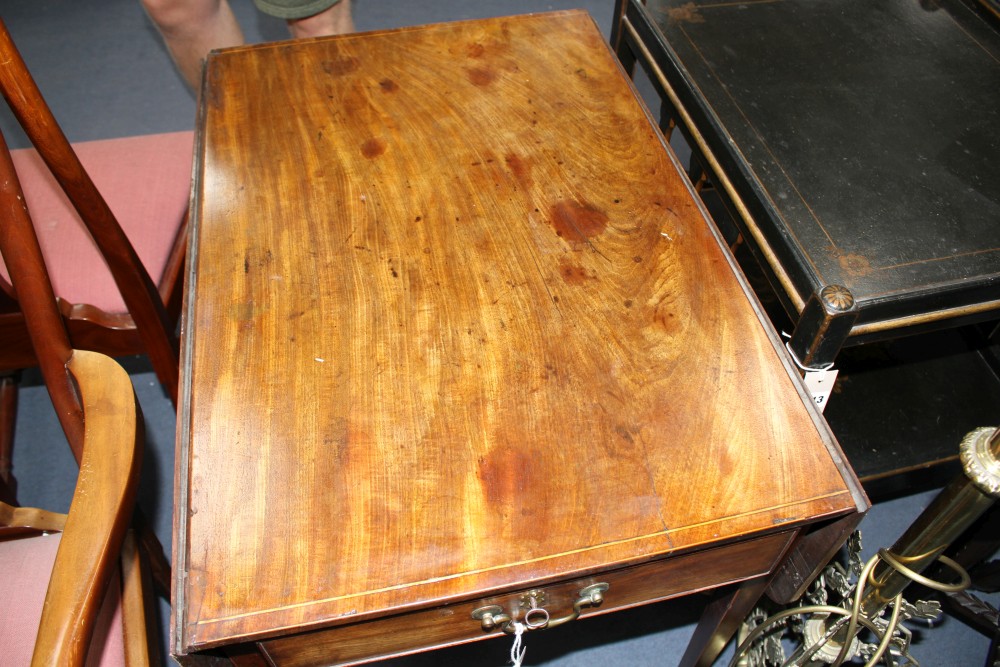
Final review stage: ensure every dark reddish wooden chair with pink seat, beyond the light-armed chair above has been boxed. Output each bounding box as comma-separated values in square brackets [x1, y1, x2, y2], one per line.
[0, 15, 193, 502]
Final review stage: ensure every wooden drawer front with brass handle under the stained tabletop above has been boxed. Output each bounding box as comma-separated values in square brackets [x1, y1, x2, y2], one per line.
[258, 531, 795, 667]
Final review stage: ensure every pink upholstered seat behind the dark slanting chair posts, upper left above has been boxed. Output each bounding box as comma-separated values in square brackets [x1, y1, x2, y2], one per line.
[0, 131, 194, 313]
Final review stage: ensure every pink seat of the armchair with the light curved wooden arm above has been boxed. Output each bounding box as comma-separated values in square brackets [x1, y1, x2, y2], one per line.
[0, 533, 125, 667]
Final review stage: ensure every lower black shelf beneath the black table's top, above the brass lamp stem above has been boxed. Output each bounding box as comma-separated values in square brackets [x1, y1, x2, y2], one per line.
[824, 329, 1000, 499]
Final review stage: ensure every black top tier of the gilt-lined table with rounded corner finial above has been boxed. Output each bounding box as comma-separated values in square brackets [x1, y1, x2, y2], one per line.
[612, 0, 1000, 367]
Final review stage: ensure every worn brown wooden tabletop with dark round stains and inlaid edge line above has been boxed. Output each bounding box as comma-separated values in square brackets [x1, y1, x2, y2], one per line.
[174, 12, 865, 653]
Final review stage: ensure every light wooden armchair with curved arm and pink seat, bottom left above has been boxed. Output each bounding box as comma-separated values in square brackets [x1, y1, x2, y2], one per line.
[0, 351, 159, 667]
